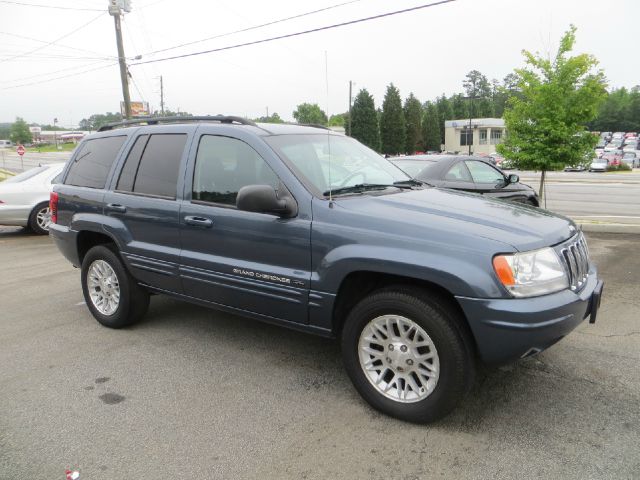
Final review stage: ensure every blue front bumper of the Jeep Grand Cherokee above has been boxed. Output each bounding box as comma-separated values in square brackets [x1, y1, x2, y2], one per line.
[456, 268, 603, 364]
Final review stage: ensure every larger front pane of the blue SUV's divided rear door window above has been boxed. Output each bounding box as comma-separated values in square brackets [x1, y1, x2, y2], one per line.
[133, 134, 187, 198]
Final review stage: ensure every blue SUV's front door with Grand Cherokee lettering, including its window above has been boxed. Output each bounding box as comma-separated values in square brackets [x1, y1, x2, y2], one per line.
[180, 135, 311, 323]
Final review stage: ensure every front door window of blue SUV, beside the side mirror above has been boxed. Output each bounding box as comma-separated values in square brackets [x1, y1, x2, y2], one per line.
[192, 135, 279, 205]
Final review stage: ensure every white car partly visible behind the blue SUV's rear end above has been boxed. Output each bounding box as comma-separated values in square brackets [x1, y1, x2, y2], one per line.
[0, 163, 64, 235]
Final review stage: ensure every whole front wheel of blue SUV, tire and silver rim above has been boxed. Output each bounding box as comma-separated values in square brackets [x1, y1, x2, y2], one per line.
[342, 287, 475, 423]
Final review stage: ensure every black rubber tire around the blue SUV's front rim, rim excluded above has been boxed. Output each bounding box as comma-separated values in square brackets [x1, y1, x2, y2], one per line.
[341, 286, 475, 423]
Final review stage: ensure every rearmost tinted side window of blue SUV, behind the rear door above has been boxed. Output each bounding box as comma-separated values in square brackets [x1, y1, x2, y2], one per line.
[64, 135, 127, 188]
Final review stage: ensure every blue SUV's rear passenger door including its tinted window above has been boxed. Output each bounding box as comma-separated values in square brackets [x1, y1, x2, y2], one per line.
[104, 127, 191, 293]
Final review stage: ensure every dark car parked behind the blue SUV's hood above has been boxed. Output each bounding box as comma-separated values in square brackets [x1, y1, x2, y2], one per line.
[391, 155, 540, 207]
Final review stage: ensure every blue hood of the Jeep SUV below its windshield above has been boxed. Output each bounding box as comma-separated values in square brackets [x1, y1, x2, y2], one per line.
[340, 188, 577, 251]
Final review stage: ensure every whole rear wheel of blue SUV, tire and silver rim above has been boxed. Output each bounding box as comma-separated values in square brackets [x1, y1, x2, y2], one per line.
[81, 245, 149, 328]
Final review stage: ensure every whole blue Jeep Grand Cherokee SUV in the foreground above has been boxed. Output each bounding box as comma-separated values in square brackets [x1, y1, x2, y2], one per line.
[50, 116, 603, 422]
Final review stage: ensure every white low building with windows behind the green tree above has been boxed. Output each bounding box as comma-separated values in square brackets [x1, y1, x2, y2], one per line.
[444, 118, 505, 154]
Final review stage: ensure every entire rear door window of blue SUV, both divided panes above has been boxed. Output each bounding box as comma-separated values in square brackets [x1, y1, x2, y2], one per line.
[116, 133, 187, 198]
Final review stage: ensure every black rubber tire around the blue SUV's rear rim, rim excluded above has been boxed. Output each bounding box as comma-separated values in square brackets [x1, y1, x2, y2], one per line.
[81, 245, 149, 328]
